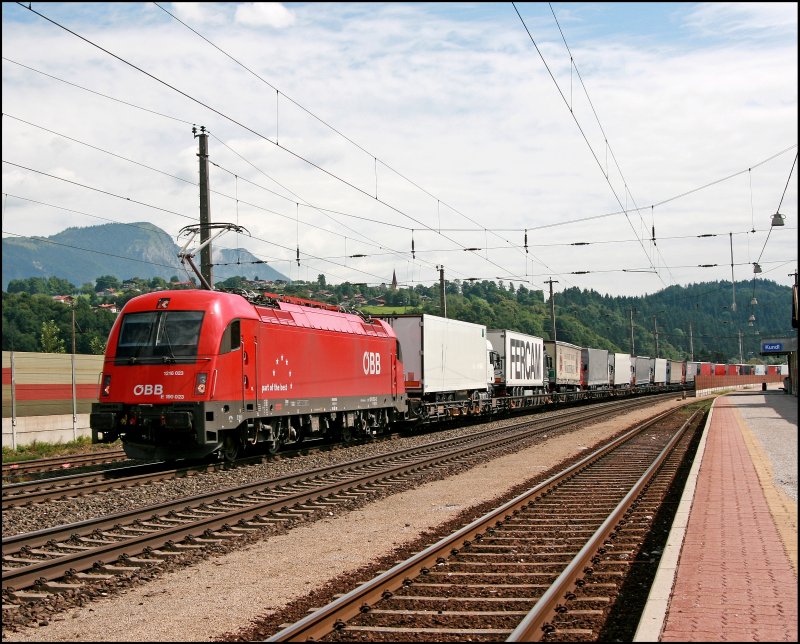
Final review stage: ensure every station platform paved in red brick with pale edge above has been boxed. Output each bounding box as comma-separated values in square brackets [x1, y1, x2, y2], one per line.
[633, 388, 798, 642]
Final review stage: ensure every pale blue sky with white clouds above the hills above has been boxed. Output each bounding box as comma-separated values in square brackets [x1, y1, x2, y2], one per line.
[2, 2, 798, 296]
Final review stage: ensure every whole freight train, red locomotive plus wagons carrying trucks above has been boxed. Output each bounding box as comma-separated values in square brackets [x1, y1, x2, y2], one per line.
[90, 290, 720, 460]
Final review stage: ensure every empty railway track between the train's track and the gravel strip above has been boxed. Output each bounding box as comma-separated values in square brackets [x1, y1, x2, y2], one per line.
[2, 401, 664, 604]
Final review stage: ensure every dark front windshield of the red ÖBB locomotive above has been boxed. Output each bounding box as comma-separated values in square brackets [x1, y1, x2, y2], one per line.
[116, 311, 203, 364]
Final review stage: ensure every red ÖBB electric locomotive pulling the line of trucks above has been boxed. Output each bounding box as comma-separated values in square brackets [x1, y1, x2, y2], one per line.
[90, 290, 406, 460]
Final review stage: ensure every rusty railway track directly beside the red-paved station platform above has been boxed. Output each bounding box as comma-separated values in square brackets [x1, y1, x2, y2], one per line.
[268, 411, 700, 642]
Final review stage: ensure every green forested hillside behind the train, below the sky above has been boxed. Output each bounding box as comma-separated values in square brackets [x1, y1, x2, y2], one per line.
[3, 275, 796, 362]
